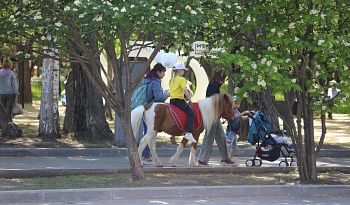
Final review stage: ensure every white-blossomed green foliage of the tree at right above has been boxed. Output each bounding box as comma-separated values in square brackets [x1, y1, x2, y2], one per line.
[202, 0, 350, 110]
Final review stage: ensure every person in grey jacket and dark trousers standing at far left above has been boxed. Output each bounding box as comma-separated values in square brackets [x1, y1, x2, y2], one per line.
[0, 59, 19, 117]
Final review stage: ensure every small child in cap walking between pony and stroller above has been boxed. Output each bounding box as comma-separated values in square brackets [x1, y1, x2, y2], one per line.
[226, 96, 249, 160]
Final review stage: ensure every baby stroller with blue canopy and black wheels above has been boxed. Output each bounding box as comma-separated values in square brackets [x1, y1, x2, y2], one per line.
[246, 111, 295, 167]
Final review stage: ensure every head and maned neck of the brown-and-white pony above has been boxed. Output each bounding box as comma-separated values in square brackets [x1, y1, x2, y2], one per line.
[198, 93, 233, 132]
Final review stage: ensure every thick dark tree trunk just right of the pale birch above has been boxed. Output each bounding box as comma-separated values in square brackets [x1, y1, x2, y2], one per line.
[63, 63, 113, 142]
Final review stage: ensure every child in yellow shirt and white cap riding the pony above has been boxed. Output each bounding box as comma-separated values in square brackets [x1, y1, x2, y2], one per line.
[169, 63, 197, 143]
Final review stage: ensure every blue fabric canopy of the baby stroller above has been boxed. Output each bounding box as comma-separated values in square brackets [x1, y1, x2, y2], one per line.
[248, 111, 272, 145]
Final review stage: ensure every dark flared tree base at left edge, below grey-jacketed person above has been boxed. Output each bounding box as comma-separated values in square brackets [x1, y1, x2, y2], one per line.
[0, 102, 22, 138]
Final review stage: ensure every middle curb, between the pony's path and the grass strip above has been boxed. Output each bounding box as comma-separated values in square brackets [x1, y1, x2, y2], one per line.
[0, 167, 350, 179]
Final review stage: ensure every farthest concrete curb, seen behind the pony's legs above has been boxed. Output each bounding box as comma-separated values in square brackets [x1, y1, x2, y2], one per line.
[0, 146, 350, 157]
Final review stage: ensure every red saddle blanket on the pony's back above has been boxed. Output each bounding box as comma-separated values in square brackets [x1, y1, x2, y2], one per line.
[167, 103, 203, 132]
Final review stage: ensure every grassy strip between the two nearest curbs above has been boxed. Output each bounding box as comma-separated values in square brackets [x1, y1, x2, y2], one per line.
[0, 171, 350, 191]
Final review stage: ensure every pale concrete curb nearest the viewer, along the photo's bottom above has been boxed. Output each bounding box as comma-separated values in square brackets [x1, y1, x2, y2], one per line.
[0, 185, 350, 203]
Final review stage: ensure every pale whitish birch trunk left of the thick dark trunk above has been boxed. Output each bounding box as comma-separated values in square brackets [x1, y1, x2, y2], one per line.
[39, 49, 60, 140]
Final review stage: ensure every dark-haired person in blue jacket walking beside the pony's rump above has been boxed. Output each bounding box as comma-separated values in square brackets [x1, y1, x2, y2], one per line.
[141, 63, 170, 165]
